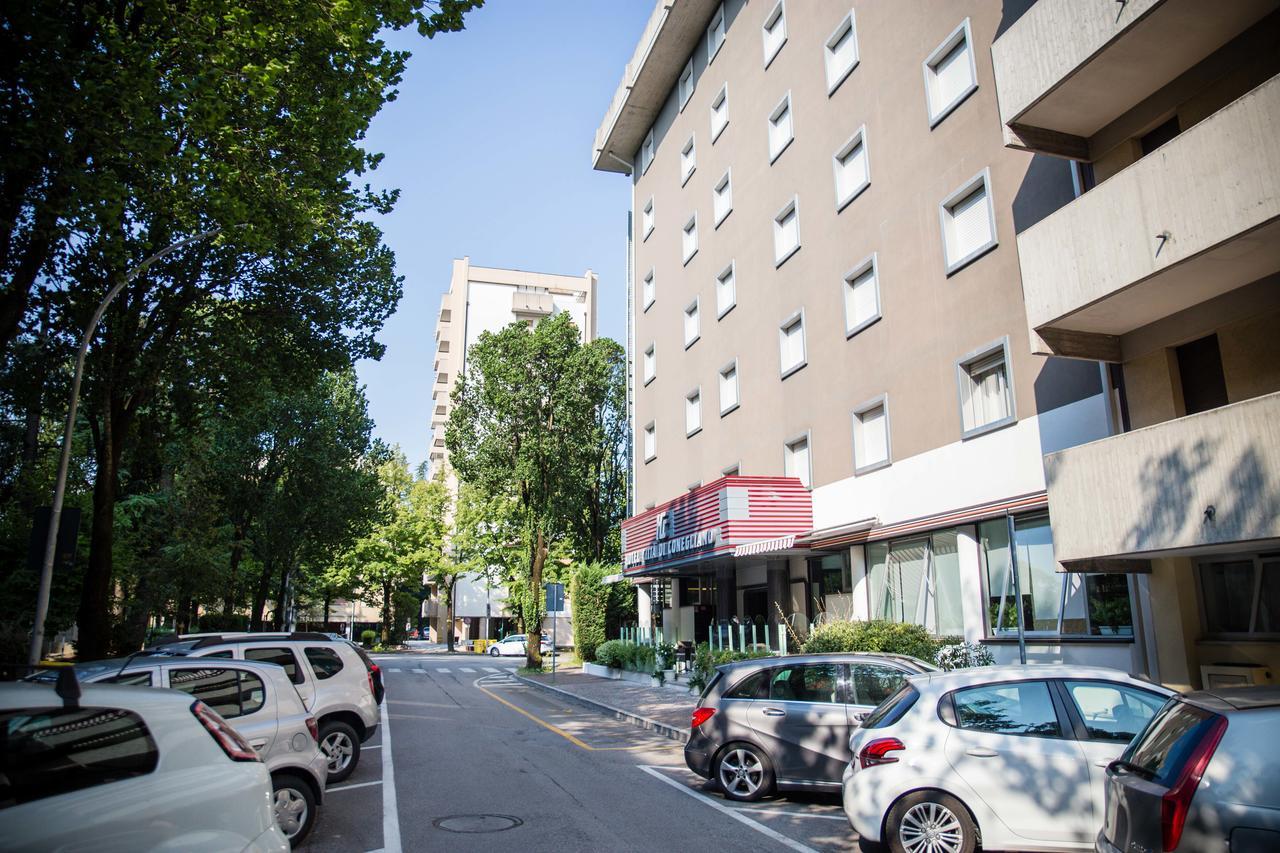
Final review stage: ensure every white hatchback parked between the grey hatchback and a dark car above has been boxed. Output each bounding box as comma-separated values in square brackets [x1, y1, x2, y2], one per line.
[842, 665, 1172, 853]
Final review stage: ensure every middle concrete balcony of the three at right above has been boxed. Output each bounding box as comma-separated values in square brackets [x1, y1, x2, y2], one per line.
[1018, 76, 1280, 361]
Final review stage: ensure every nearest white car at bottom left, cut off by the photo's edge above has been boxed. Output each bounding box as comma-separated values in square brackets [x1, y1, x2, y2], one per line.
[0, 681, 289, 853]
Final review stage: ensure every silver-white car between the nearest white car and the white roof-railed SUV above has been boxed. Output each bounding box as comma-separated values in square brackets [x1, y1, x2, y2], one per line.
[43, 657, 329, 845]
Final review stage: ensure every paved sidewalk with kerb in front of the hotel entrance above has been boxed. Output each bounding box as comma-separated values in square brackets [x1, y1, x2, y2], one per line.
[516, 667, 698, 743]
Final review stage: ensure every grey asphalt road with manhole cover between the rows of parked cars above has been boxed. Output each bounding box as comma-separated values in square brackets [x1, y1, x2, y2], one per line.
[300, 654, 856, 853]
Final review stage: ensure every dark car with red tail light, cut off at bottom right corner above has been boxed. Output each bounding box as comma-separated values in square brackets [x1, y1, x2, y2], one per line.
[1096, 685, 1280, 853]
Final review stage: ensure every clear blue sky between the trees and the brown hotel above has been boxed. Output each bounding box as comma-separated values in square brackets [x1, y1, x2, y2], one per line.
[358, 0, 653, 465]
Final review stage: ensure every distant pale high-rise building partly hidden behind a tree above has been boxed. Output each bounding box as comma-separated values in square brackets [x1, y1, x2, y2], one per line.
[424, 257, 596, 639]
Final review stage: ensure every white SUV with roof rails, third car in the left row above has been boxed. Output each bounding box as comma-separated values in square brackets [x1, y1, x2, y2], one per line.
[152, 631, 380, 784]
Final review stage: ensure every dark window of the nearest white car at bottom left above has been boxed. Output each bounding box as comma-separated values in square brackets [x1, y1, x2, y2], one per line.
[0, 708, 160, 809]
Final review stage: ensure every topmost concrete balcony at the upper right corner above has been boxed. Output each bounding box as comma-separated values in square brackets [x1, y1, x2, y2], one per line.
[991, 0, 1280, 160]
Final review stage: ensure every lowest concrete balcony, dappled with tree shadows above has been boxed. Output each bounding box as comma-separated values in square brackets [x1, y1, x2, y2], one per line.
[1044, 393, 1280, 570]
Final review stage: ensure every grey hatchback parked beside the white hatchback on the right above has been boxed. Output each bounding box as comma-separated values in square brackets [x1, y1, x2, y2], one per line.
[685, 653, 937, 800]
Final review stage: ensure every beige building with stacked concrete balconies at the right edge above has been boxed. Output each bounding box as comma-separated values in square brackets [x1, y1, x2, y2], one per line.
[992, 0, 1280, 686]
